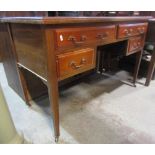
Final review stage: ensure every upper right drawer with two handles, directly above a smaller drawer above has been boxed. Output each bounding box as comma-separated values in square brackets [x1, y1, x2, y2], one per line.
[118, 23, 148, 38]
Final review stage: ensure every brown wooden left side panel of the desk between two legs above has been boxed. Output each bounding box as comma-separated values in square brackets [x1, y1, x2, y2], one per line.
[11, 24, 47, 79]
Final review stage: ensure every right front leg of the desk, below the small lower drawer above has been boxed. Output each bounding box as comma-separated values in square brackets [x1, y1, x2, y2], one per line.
[133, 50, 143, 87]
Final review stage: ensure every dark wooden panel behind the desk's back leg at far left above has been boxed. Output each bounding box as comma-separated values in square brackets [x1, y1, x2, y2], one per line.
[0, 23, 24, 99]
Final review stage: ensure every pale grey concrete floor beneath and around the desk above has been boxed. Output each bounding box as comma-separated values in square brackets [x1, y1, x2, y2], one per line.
[0, 64, 155, 144]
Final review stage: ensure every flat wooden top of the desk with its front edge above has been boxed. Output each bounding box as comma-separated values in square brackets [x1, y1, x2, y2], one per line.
[0, 16, 153, 25]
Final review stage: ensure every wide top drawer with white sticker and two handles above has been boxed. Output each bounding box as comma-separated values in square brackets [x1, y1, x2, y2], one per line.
[55, 25, 116, 48]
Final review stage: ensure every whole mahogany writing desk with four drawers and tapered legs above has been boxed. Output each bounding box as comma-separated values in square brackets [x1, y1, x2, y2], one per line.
[0, 17, 150, 141]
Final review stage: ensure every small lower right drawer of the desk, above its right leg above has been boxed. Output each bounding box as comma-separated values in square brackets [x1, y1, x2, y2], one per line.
[127, 36, 144, 55]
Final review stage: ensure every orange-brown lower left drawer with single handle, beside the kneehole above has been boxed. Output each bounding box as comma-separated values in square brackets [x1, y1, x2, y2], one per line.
[57, 48, 96, 80]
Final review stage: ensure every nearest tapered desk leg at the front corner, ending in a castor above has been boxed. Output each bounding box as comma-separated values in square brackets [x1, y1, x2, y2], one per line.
[45, 30, 60, 142]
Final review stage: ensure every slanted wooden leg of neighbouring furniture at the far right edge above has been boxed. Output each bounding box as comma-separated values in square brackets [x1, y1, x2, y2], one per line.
[145, 50, 155, 86]
